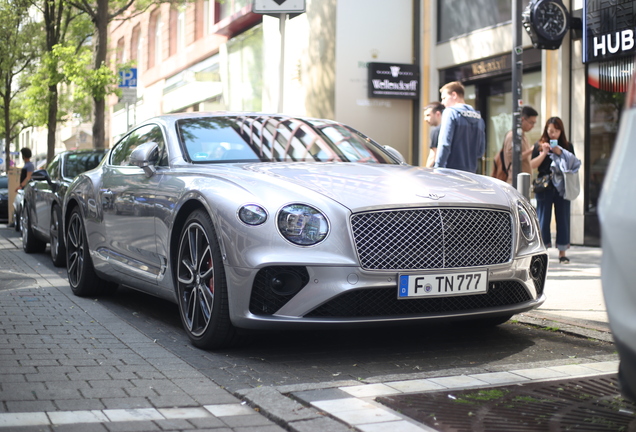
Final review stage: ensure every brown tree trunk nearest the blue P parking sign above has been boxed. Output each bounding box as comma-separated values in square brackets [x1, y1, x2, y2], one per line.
[93, 0, 108, 149]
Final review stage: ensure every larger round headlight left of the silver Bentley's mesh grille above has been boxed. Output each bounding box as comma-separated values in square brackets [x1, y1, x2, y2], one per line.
[278, 204, 329, 246]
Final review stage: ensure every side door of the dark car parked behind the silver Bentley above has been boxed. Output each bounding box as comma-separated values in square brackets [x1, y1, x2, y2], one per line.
[30, 153, 64, 241]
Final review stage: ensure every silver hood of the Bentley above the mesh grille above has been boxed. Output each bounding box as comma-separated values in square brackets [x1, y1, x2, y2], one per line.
[243, 162, 512, 211]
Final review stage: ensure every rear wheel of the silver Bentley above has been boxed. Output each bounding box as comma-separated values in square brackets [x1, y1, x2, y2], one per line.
[66, 208, 117, 297]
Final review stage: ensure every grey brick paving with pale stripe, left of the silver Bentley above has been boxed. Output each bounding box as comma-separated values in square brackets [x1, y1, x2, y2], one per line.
[0, 225, 284, 432]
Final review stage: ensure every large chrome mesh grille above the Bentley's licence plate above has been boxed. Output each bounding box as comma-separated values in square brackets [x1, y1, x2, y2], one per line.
[351, 208, 512, 270]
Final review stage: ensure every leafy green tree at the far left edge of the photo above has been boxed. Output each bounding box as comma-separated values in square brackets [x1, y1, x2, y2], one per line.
[0, 0, 42, 166]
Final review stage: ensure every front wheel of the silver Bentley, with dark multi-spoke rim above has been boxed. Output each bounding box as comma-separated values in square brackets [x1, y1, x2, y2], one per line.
[175, 210, 236, 349]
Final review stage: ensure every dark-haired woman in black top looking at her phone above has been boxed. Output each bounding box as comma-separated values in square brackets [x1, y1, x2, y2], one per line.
[530, 117, 574, 264]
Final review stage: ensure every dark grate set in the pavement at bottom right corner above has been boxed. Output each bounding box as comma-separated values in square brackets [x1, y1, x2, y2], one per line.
[376, 374, 636, 432]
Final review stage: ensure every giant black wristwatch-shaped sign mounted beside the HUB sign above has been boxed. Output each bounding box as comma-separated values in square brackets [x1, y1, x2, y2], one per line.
[522, 0, 570, 50]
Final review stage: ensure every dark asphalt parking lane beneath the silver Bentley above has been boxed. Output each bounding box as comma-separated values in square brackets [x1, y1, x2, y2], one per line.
[27, 246, 616, 392]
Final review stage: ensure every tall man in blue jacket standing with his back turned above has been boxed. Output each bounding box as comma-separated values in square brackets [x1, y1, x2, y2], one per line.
[435, 81, 486, 173]
